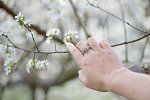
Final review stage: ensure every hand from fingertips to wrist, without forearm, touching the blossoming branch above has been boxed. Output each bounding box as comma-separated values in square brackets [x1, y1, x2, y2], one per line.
[66, 38, 123, 91]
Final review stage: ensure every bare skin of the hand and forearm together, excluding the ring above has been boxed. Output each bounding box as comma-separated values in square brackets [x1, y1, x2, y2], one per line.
[66, 38, 150, 100]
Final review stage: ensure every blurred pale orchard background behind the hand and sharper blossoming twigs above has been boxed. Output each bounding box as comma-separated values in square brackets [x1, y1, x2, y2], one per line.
[0, 0, 150, 100]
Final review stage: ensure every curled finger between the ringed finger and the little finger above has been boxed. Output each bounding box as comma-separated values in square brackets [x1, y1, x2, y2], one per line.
[87, 38, 101, 51]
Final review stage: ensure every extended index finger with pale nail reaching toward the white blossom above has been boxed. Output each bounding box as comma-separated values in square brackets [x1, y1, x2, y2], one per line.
[66, 42, 83, 64]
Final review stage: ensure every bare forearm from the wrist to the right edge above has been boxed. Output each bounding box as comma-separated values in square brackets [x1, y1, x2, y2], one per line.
[111, 69, 150, 100]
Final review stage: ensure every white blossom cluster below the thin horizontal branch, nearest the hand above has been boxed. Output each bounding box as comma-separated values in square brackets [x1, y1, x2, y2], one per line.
[26, 59, 49, 73]
